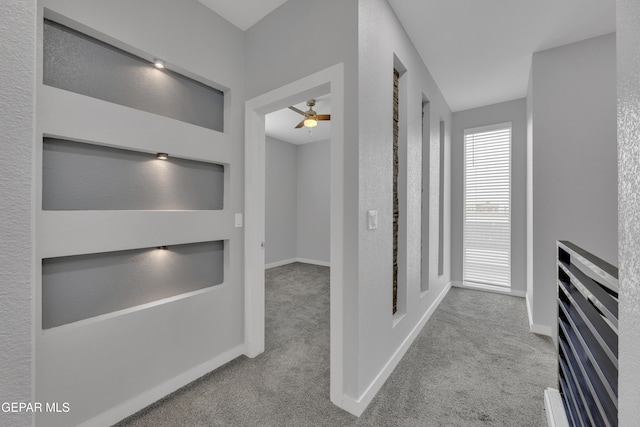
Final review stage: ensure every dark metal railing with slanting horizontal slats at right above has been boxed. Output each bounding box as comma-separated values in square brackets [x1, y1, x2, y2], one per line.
[557, 241, 618, 427]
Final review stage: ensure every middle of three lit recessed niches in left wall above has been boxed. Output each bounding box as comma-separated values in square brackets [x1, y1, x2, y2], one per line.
[42, 138, 225, 210]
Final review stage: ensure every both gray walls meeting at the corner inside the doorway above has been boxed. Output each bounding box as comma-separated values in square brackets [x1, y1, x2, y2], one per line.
[265, 137, 331, 265]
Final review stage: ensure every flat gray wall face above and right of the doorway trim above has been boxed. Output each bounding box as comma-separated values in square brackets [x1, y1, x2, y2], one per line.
[245, 0, 360, 405]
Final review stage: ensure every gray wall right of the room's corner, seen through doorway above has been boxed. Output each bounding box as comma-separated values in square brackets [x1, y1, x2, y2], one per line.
[296, 141, 331, 263]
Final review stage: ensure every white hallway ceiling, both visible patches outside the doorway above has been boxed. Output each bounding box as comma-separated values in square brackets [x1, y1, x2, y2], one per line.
[199, 0, 615, 119]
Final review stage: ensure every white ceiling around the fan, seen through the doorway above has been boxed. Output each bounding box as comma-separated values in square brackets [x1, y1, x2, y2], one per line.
[264, 95, 331, 145]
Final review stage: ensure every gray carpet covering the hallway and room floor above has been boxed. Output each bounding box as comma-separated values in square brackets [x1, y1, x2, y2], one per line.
[118, 263, 556, 427]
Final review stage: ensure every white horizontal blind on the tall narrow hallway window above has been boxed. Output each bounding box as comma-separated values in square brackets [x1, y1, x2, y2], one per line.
[463, 123, 511, 287]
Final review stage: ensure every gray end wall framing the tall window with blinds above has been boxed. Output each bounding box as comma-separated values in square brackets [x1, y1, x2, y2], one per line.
[451, 99, 527, 295]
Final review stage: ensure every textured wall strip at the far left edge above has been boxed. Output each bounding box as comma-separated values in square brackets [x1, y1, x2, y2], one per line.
[0, 0, 36, 426]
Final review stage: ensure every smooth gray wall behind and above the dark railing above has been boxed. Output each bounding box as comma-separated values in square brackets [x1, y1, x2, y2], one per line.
[528, 34, 618, 330]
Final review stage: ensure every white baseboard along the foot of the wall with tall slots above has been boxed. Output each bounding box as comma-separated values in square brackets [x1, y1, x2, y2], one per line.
[342, 283, 451, 417]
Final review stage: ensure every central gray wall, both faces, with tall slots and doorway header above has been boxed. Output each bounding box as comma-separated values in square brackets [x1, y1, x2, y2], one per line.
[246, 0, 451, 413]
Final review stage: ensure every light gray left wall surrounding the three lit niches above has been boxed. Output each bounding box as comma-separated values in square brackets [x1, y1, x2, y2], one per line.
[31, 0, 245, 426]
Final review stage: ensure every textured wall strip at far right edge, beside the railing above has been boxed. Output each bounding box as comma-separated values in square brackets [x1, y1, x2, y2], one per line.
[616, 0, 640, 427]
